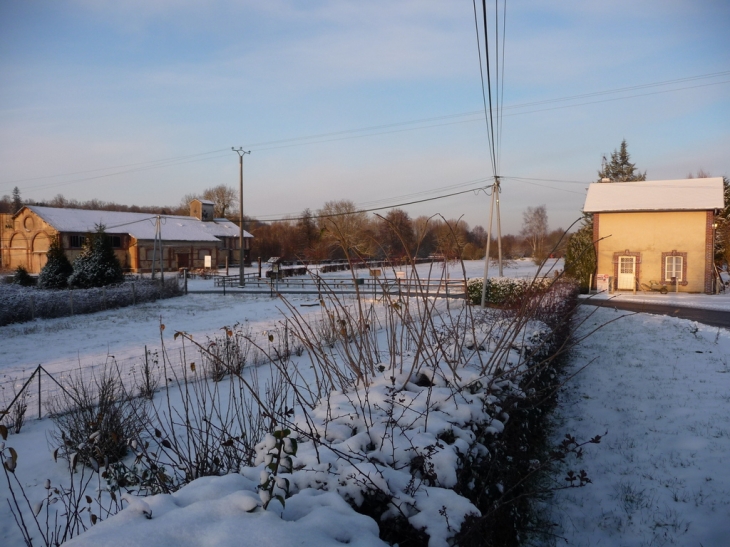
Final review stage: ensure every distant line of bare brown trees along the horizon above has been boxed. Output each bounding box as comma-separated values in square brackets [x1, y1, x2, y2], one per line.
[0, 189, 565, 261]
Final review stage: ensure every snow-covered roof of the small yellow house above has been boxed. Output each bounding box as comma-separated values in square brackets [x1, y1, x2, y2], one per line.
[583, 177, 725, 213]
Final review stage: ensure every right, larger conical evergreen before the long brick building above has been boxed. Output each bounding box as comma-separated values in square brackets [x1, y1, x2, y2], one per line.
[68, 224, 124, 288]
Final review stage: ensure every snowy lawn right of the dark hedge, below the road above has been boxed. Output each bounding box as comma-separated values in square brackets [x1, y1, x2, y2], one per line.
[551, 309, 730, 547]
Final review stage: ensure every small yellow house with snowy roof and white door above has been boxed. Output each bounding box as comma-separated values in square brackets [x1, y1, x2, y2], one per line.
[583, 177, 724, 294]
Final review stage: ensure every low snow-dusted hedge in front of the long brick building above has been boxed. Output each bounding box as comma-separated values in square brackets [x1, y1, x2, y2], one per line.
[0, 279, 181, 326]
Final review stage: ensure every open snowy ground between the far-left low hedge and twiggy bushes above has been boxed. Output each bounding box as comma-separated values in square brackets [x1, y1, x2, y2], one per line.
[0, 260, 562, 382]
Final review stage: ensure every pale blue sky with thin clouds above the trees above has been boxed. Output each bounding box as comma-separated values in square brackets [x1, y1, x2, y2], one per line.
[0, 0, 730, 233]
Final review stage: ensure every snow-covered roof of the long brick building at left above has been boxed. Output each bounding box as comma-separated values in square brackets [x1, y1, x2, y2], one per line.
[28, 205, 253, 241]
